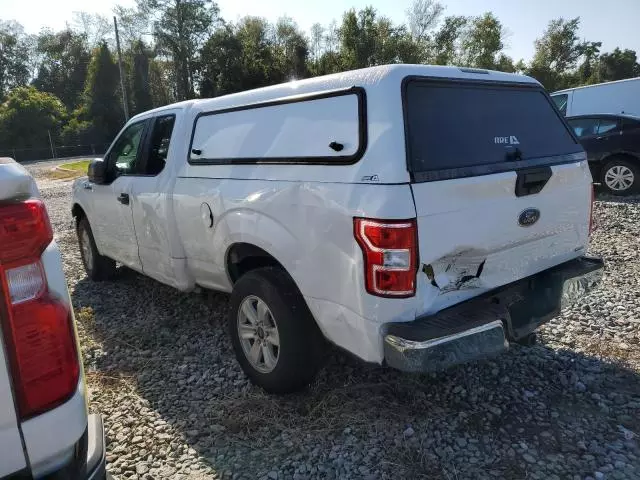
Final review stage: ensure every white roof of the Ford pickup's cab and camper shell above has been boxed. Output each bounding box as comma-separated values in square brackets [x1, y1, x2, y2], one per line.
[134, 64, 538, 118]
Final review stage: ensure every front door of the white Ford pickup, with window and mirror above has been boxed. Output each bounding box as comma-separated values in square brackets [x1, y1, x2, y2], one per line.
[81, 120, 149, 270]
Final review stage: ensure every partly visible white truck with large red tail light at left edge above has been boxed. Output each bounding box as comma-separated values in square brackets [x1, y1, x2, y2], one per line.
[0, 158, 105, 480]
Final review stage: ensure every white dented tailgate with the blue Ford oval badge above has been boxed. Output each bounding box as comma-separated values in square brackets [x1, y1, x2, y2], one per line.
[412, 161, 591, 313]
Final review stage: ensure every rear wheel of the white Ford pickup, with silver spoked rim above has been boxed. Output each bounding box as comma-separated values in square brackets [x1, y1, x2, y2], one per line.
[228, 267, 324, 393]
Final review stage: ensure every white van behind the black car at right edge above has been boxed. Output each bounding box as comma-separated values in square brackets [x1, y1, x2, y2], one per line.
[551, 77, 640, 117]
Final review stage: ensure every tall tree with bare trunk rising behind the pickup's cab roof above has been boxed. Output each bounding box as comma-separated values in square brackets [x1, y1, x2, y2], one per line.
[138, 0, 218, 100]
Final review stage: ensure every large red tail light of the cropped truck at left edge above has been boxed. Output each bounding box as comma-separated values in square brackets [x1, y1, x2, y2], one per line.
[0, 200, 80, 420]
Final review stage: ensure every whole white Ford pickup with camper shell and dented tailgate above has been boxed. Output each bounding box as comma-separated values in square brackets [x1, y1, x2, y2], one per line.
[73, 65, 603, 392]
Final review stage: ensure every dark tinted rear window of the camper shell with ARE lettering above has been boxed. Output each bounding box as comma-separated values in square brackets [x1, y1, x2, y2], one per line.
[405, 81, 581, 172]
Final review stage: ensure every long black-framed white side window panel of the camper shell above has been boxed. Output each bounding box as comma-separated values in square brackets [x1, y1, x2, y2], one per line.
[190, 89, 366, 164]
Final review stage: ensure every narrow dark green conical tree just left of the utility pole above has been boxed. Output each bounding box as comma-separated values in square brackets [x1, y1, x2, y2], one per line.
[81, 42, 124, 143]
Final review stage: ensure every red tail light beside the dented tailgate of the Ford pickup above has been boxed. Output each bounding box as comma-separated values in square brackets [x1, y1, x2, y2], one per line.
[353, 218, 418, 297]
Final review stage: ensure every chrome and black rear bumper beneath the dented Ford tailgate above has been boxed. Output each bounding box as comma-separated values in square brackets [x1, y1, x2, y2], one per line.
[384, 257, 604, 372]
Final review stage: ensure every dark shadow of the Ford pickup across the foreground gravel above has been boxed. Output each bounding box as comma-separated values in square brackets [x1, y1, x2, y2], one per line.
[72, 271, 640, 478]
